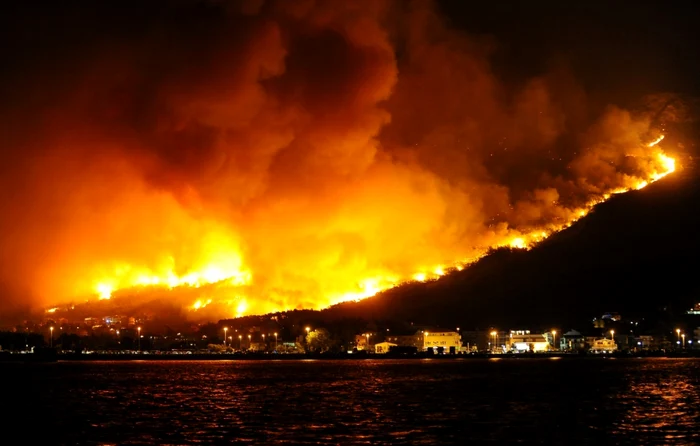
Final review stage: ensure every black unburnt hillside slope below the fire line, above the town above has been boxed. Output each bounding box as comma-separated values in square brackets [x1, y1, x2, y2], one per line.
[323, 136, 700, 329]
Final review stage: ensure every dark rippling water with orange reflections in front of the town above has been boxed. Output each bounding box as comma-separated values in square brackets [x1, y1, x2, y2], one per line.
[0, 358, 700, 445]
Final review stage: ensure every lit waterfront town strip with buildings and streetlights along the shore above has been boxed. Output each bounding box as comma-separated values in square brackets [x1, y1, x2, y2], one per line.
[0, 303, 700, 358]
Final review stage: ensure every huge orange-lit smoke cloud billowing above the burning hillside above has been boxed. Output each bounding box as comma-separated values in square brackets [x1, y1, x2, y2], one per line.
[0, 0, 663, 317]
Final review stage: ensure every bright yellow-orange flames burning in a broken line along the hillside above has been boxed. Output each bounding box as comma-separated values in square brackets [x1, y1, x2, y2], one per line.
[80, 135, 676, 317]
